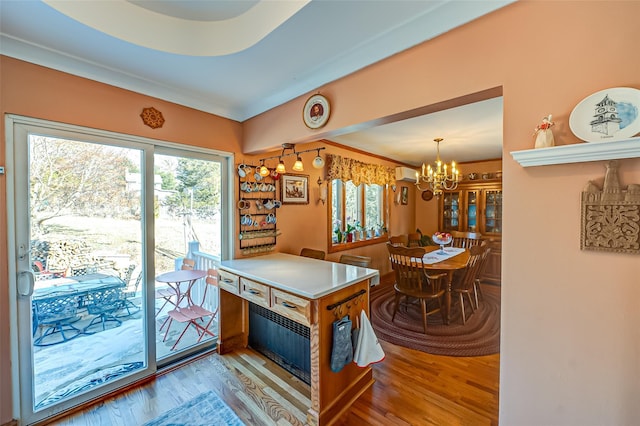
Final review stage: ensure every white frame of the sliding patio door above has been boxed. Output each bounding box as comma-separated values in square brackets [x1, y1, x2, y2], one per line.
[5, 114, 234, 424]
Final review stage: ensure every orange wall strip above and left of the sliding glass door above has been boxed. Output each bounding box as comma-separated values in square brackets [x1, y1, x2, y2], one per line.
[0, 56, 242, 424]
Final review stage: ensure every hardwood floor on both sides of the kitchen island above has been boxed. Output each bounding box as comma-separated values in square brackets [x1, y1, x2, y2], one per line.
[51, 341, 500, 426]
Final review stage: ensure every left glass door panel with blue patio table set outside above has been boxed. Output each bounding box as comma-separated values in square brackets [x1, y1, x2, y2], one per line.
[12, 129, 150, 424]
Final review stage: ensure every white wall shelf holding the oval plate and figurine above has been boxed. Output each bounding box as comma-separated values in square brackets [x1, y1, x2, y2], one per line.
[511, 137, 640, 167]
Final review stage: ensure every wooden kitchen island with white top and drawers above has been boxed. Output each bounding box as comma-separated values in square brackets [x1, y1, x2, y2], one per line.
[218, 253, 379, 425]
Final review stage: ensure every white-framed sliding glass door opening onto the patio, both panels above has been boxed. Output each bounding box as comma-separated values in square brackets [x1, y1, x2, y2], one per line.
[7, 116, 228, 424]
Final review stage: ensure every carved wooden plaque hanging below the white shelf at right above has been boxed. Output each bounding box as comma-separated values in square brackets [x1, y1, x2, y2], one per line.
[580, 160, 640, 254]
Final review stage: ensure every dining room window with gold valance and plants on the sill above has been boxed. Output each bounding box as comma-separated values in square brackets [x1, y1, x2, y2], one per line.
[327, 155, 395, 251]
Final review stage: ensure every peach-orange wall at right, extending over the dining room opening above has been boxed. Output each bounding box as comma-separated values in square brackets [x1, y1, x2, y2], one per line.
[244, 1, 640, 425]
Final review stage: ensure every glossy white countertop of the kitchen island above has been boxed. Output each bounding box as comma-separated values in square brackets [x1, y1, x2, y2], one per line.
[220, 253, 380, 299]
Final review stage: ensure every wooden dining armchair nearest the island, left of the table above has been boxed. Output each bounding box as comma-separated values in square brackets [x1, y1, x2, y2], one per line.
[387, 243, 447, 334]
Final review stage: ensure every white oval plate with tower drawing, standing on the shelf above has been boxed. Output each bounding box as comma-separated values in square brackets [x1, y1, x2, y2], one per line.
[569, 87, 640, 142]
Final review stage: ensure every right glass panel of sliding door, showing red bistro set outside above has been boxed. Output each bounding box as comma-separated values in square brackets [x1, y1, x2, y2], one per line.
[154, 150, 222, 364]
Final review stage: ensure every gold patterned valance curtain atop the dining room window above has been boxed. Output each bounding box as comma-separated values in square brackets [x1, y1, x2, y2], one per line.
[327, 154, 396, 186]
